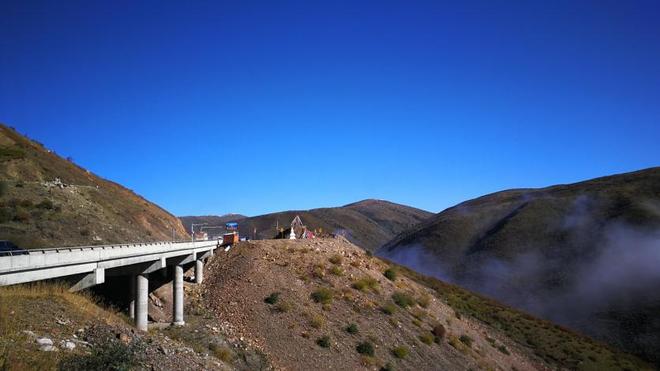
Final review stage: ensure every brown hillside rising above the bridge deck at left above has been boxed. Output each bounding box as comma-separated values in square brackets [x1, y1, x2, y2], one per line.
[0, 125, 188, 248]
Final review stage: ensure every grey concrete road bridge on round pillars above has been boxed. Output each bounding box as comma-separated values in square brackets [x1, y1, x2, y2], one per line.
[0, 241, 220, 331]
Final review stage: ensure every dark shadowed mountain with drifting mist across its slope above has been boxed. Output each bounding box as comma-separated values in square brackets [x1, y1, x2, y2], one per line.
[378, 168, 660, 364]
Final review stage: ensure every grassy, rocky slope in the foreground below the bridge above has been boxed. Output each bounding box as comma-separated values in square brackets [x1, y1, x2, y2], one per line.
[0, 284, 233, 370]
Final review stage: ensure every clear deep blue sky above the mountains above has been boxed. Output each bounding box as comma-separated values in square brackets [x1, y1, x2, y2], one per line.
[0, 0, 660, 215]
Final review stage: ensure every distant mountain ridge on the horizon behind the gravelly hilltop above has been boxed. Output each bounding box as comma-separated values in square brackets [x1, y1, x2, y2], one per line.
[186, 200, 433, 251]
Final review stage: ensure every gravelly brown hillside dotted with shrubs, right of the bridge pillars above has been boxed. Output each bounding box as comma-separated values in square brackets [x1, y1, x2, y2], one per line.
[201, 238, 648, 370]
